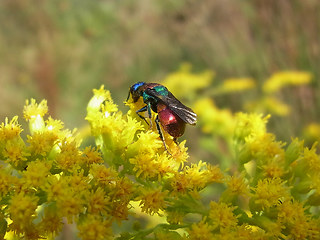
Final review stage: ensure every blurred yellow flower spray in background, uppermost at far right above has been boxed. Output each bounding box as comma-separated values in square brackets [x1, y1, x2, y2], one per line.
[263, 71, 312, 93]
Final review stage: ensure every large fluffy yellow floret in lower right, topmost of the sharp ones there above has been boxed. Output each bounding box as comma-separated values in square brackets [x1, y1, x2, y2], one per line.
[252, 178, 290, 211]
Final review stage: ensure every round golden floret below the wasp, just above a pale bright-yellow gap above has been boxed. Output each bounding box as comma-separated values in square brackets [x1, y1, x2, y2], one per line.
[137, 188, 168, 215]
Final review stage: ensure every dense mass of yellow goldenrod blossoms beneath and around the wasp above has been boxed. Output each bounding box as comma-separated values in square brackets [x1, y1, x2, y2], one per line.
[0, 68, 320, 240]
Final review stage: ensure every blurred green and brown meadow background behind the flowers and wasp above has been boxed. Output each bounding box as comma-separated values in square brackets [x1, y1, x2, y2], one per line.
[0, 0, 320, 146]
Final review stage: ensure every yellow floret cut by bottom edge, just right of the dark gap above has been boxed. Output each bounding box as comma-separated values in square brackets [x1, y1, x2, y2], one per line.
[77, 215, 113, 240]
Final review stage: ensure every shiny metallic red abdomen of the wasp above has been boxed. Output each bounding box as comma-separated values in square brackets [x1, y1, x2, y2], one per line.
[157, 104, 186, 138]
